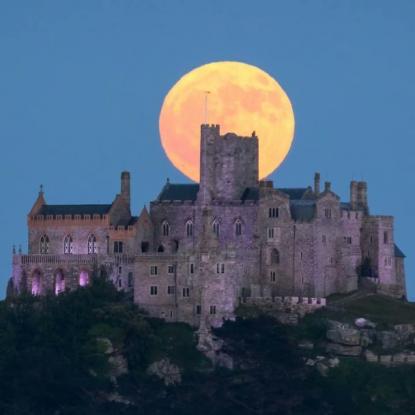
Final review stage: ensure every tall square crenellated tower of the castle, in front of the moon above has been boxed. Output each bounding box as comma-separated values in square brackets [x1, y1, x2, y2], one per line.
[199, 124, 258, 203]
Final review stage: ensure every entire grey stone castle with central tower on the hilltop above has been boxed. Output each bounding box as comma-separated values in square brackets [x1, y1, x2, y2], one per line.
[9, 124, 406, 325]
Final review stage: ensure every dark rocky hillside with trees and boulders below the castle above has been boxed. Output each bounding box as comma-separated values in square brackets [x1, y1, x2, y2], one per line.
[0, 279, 415, 415]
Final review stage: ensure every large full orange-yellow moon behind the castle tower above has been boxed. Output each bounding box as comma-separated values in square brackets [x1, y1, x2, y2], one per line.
[159, 62, 295, 182]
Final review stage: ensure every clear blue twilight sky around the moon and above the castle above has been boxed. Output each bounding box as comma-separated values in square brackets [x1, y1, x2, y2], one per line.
[0, 0, 415, 299]
